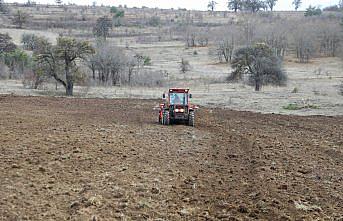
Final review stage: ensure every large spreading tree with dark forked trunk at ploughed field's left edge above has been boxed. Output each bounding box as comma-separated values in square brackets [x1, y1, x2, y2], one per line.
[37, 37, 94, 96]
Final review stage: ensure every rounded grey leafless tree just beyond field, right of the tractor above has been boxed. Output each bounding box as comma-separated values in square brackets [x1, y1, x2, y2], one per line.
[229, 44, 287, 91]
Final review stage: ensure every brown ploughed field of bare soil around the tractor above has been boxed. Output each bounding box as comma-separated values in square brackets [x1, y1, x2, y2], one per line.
[0, 96, 343, 220]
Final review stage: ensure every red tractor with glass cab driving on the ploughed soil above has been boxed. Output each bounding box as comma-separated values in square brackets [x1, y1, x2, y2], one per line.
[158, 88, 197, 127]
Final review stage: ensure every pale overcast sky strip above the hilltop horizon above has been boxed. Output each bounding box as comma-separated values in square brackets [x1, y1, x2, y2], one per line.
[5, 0, 339, 10]
